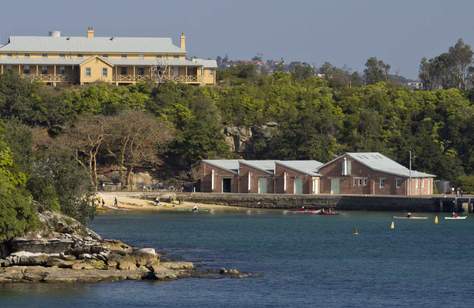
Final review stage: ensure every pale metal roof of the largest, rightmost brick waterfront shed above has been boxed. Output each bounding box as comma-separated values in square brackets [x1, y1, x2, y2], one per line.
[346, 152, 435, 177]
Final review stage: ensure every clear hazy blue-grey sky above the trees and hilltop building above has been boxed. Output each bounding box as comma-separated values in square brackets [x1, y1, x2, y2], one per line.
[0, 0, 474, 78]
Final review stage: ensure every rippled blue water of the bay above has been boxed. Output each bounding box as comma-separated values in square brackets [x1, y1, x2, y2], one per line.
[0, 212, 474, 308]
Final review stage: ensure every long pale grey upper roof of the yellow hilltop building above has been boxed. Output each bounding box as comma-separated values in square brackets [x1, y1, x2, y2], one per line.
[0, 36, 185, 54]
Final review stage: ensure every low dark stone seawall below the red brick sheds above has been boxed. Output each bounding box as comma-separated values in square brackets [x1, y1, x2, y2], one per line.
[144, 193, 474, 212]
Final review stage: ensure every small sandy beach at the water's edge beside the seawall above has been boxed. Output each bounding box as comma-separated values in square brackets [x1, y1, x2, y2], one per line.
[97, 192, 246, 212]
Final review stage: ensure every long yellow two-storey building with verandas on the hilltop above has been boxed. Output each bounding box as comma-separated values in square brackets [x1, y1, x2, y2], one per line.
[0, 28, 217, 86]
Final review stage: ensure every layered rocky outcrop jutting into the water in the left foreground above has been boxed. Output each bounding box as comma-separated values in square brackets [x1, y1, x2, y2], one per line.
[0, 212, 244, 283]
